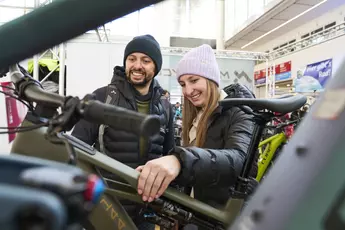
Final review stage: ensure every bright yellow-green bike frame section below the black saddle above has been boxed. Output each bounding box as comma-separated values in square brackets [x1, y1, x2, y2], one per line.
[256, 132, 286, 181]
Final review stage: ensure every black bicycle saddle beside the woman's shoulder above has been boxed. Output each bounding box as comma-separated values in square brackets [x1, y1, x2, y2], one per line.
[219, 94, 307, 113]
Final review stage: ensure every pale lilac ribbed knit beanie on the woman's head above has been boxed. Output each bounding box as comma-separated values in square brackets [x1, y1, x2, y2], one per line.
[176, 44, 220, 86]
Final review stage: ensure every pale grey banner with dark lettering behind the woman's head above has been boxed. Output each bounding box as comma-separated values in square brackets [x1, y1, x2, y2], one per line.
[156, 54, 255, 99]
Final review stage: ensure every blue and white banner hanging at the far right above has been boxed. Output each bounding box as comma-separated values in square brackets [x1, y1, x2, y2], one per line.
[294, 59, 332, 93]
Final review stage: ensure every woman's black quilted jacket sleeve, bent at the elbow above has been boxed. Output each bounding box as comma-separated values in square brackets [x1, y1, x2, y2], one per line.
[172, 107, 254, 186]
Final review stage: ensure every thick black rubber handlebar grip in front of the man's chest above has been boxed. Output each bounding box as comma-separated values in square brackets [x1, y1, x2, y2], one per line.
[82, 100, 160, 136]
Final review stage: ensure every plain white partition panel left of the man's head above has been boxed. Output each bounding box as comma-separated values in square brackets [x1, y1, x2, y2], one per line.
[66, 42, 126, 98]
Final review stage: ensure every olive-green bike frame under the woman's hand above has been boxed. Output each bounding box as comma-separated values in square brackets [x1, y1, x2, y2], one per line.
[11, 121, 234, 230]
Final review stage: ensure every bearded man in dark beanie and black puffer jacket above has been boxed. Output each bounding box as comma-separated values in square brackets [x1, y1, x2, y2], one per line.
[72, 35, 174, 229]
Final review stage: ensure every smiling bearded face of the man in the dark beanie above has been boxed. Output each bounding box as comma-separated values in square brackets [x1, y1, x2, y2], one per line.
[126, 53, 155, 87]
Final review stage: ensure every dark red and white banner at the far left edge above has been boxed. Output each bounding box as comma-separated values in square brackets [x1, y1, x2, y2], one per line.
[1, 82, 27, 143]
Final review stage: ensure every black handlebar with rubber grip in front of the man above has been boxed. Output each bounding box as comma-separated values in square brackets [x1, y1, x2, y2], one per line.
[9, 65, 160, 136]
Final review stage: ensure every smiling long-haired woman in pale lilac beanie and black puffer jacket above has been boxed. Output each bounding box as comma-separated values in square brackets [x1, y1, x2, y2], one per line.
[137, 45, 256, 207]
